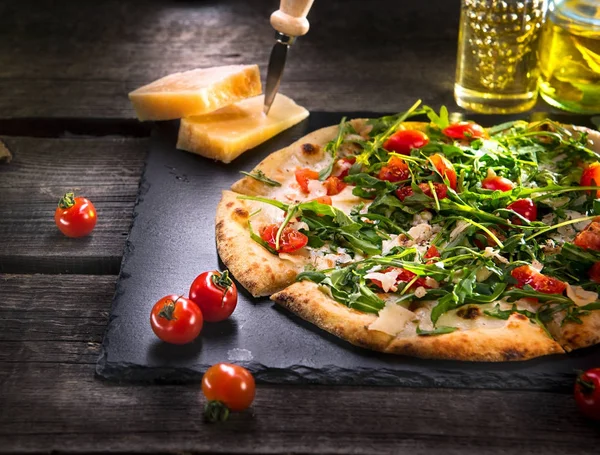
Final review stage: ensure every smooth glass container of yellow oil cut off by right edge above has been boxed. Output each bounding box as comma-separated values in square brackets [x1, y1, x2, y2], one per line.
[539, 0, 600, 114]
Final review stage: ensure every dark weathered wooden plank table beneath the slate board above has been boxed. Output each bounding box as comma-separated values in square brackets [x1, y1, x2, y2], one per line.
[0, 0, 600, 454]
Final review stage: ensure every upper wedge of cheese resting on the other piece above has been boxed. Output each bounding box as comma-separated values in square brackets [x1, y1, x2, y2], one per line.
[129, 65, 262, 121]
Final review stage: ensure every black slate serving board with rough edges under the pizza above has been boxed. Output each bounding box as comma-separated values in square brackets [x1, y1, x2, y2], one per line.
[97, 112, 600, 390]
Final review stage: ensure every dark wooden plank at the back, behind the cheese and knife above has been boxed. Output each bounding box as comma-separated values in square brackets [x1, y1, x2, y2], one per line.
[0, 0, 459, 118]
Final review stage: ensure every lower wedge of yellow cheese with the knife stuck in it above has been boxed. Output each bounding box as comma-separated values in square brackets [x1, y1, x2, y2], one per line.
[177, 94, 308, 163]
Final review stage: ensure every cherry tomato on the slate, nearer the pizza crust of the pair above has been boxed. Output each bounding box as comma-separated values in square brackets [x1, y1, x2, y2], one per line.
[190, 270, 237, 322]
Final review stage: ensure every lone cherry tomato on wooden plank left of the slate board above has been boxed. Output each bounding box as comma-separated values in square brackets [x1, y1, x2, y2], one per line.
[54, 193, 98, 237]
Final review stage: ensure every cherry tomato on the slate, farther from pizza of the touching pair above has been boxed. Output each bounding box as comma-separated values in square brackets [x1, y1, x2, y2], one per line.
[150, 294, 203, 344]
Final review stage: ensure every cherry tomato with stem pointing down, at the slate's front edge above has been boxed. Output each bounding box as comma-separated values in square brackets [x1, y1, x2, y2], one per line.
[202, 363, 256, 422]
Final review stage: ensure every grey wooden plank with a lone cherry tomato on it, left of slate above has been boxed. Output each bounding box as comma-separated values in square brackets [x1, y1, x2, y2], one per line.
[0, 137, 148, 274]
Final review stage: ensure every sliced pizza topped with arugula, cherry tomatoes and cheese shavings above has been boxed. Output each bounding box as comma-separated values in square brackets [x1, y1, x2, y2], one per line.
[216, 104, 600, 361]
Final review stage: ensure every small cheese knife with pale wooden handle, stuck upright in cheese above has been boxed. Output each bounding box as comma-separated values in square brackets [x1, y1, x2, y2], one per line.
[264, 0, 314, 115]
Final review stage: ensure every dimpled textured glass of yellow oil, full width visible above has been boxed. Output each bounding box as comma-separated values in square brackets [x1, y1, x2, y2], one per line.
[454, 0, 546, 114]
